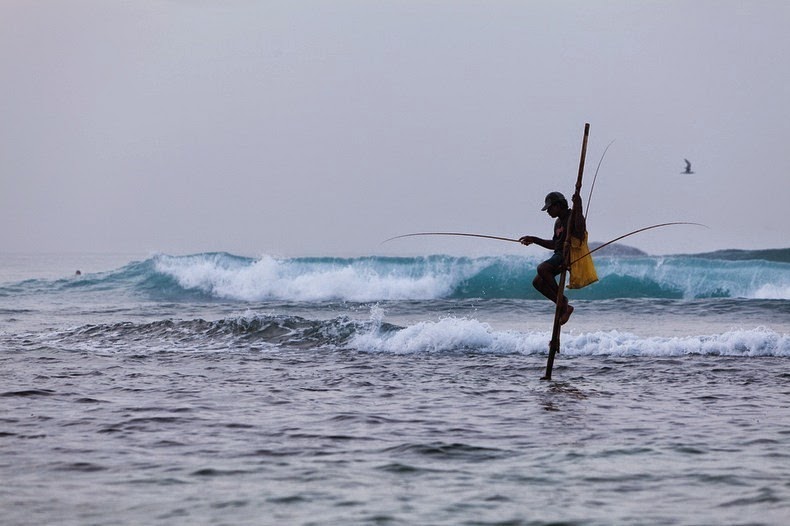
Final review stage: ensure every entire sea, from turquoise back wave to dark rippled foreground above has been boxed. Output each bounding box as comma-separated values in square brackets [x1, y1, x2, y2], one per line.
[0, 250, 790, 525]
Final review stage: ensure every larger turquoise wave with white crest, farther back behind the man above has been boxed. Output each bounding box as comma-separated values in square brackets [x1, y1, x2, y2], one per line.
[6, 251, 790, 302]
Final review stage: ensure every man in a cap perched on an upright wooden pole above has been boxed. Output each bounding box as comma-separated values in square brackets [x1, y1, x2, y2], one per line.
[519, 192, 587, 325]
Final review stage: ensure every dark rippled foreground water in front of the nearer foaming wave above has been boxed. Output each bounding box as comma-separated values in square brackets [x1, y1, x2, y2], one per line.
[0, 348, 790, 524]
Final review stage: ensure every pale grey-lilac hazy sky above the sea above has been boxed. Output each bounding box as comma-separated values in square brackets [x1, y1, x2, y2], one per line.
[0, 0, 790, 256]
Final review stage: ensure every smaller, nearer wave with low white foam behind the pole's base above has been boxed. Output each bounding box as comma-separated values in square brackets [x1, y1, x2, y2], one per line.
[13, 314, 790, 357]
